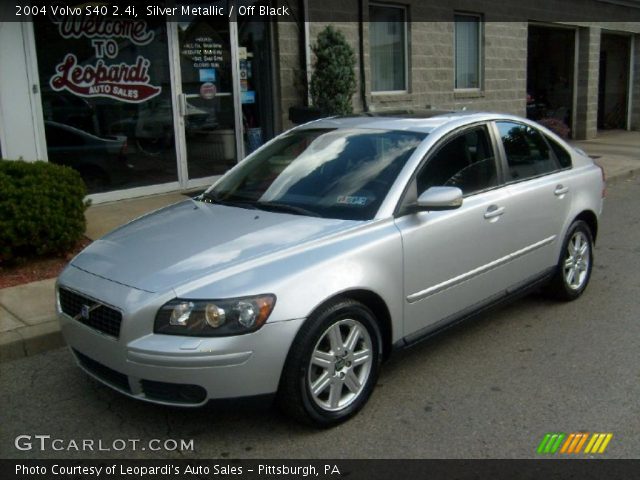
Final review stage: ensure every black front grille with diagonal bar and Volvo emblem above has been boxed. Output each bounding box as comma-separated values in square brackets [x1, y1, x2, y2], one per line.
[58, 288, 122, 338]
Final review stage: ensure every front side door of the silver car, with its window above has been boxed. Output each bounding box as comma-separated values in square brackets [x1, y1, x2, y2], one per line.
[396, 124, 510, 341]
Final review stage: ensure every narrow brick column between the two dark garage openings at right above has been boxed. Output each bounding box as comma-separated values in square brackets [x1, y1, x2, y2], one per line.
[574, 27, 601, 140]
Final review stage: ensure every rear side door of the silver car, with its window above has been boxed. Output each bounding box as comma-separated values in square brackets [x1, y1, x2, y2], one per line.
[494, 121, 573, 287]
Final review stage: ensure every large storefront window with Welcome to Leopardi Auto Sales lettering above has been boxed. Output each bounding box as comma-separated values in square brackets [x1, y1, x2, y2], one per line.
[34, 11, 178, 193]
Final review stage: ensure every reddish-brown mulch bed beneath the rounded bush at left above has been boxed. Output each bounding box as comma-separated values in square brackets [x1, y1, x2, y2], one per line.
[0, 237, 91, 288]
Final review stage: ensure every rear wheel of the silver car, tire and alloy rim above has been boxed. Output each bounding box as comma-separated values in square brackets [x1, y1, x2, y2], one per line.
[547, 220, 593, 301]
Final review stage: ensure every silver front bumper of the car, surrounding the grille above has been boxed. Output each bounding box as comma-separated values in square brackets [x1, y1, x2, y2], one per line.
[58, 269, 303, 406]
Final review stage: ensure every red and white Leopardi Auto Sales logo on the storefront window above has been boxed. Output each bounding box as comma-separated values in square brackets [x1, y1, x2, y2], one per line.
[49, 53, 162, 103]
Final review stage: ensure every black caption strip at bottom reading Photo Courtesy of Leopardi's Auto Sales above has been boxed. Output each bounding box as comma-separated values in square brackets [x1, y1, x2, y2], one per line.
[0, 460, 640, 480]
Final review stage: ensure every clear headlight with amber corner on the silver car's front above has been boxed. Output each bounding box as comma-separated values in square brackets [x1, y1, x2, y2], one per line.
[153, 294, 276, 337]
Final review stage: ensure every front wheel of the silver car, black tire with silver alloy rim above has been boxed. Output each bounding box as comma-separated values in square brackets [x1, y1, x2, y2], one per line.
[278, 299, 382, 427]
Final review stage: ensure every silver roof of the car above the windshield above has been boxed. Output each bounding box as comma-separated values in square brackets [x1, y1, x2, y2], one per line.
[299, 110, 522, 133]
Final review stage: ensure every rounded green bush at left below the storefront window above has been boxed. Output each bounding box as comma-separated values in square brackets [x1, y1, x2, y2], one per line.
[0, 160, 88, 263]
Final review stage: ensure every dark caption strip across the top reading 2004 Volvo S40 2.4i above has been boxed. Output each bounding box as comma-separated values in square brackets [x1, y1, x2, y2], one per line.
[0, 0, 640, 22]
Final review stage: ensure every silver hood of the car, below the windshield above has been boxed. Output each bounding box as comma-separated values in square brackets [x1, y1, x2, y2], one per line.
[71, 200, 360, 292]
